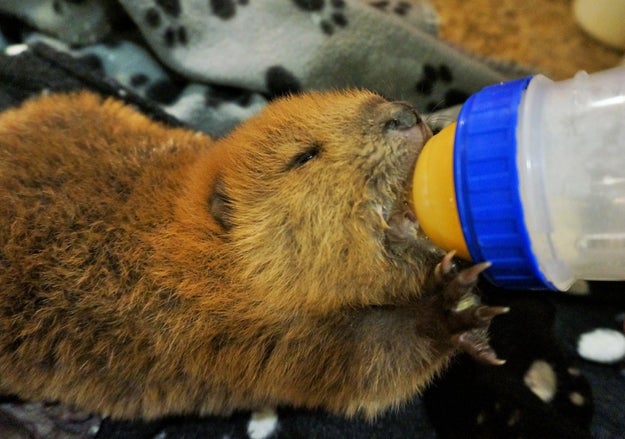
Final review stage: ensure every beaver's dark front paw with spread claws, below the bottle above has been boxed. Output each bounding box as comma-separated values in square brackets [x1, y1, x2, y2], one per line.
[435, 252, 509, 365]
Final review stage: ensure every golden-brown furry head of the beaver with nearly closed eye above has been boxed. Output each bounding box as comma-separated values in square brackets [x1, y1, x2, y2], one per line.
[209, 91, 440, 307]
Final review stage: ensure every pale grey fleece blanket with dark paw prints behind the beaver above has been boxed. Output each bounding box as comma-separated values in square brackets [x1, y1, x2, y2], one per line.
[0, 0, 523, 136]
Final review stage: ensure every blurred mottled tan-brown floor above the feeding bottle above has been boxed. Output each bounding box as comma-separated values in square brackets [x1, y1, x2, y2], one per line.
[429, 0, 625, 79]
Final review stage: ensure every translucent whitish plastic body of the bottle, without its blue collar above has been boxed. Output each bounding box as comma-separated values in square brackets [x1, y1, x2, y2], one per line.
[517, 67, 625, 290]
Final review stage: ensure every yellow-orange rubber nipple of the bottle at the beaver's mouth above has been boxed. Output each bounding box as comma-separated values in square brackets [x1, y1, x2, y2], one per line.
[412, 123, 471, 261]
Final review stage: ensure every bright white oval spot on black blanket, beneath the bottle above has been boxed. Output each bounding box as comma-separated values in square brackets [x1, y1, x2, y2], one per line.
[577, 328, 625, 364]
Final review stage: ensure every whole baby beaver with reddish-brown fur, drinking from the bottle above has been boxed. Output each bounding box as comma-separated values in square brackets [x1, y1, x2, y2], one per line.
[0, 91, 501, 418]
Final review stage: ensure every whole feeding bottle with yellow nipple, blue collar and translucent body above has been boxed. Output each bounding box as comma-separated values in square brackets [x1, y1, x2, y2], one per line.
[413, 67, 625, 290]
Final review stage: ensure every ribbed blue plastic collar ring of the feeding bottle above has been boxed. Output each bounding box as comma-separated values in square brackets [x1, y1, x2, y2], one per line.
[454, 77, 553, 289]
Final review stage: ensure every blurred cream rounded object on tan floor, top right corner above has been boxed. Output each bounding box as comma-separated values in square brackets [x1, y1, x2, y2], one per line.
[573, 0, 625, 49]
